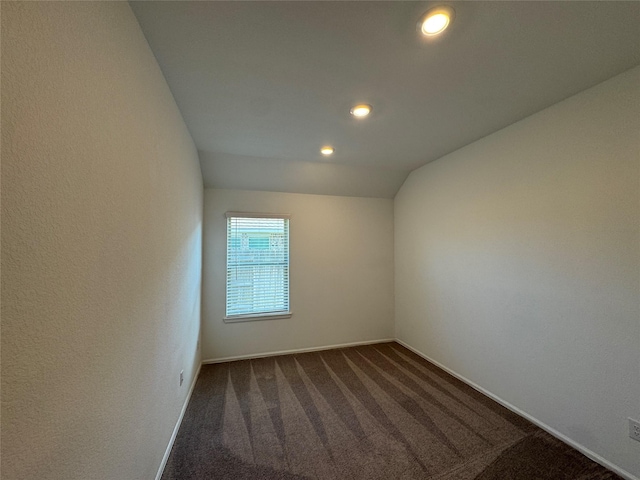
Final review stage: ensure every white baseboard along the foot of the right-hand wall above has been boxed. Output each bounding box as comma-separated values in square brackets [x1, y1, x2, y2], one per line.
[395, 338, 640, 480]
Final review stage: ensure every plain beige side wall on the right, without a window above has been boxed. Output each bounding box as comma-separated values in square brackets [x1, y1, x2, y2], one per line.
[395, 67, 640, 475]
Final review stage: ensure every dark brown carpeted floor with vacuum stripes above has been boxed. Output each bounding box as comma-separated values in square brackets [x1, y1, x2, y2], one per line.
[162, 343, 620, 480]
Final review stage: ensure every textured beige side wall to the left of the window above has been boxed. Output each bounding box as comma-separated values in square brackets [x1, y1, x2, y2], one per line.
[2, 2, 202, 480]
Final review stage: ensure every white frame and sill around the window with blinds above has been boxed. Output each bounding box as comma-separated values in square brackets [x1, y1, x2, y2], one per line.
[223, 212, 293, 323]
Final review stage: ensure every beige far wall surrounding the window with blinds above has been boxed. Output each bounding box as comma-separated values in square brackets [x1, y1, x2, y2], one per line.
[202, 189, 393, 360]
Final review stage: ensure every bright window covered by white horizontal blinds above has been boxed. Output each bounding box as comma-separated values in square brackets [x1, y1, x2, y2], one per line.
[225, 212, 291, 321]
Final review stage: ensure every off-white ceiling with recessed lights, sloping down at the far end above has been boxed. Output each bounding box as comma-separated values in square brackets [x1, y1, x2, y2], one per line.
[130, 1, 640, 197]
